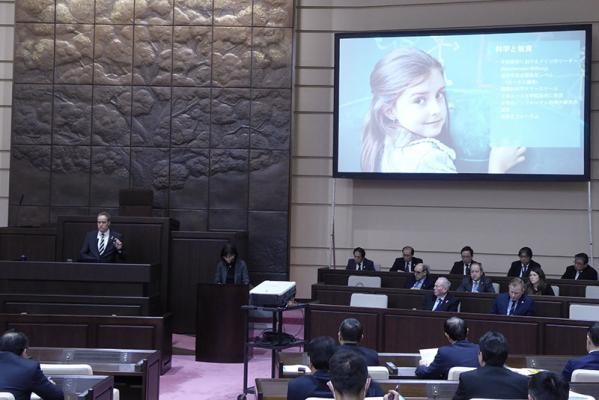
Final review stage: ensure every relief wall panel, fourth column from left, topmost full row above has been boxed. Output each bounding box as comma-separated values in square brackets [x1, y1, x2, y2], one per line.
[133, 26, 173, 86]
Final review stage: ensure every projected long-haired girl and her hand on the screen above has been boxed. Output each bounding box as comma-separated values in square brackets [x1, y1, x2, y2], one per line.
[361, 47, 525, 173]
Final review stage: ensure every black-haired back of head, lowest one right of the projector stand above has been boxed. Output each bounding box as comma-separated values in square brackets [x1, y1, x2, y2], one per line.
[329, 350, 368, 399]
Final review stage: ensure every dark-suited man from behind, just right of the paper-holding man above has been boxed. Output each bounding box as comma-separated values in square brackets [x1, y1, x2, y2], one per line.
[453, 331, 528, 400]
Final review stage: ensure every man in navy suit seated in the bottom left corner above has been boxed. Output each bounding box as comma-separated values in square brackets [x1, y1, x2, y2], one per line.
[0, 332, 64, 400]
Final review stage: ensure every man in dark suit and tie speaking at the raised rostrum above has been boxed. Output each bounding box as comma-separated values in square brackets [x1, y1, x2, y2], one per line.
[79, 211, 125, 263]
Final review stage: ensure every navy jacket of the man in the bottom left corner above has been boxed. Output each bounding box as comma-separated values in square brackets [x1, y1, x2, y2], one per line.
[0, 351, 64, 400]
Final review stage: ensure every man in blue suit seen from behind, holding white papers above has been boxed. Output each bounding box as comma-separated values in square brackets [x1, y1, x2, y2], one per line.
[416, 317, 478, 379]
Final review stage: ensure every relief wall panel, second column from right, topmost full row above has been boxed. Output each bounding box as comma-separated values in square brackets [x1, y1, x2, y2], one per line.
[212, 28, 252, 87]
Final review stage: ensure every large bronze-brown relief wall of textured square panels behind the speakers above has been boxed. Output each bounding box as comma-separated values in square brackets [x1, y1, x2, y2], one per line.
[9, 0, 293, 279]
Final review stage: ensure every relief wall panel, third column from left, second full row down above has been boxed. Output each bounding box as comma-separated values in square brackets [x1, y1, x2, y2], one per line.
[92, 86, 131, 146]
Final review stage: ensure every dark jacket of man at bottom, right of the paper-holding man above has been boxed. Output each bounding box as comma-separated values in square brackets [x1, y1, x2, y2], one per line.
[453, 366, 528, 400]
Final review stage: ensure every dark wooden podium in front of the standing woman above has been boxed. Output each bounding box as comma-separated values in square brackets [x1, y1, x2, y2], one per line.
[196, 283, 249, 363]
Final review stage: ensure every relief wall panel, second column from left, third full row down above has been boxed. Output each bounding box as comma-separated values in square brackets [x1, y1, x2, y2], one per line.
[51, 146, 91, 206]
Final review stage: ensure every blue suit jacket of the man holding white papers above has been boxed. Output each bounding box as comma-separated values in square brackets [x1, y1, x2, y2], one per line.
[416, 340, 479, 379]
